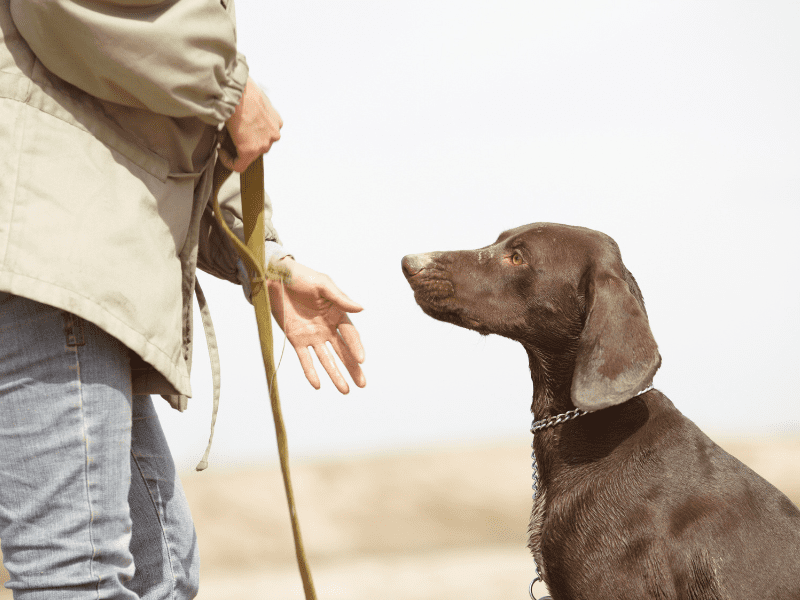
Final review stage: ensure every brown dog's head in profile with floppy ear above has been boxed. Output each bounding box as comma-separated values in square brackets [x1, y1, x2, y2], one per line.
[402, 223, 661, 411]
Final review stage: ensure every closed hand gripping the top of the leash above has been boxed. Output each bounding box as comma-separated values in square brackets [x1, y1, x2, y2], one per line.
[219, 77, 283, 173]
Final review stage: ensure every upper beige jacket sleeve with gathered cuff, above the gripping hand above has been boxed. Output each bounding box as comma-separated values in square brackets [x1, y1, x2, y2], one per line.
[11, 0, 248, 125]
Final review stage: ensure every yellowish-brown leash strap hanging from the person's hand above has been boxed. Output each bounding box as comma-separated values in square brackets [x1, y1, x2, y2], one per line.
[212, 156, 317, 600]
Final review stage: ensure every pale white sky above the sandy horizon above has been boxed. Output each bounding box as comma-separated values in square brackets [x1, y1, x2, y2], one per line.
[153, 0, 800, 468]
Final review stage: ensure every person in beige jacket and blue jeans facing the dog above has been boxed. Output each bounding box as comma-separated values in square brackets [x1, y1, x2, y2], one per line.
[0, 0, 366, 600]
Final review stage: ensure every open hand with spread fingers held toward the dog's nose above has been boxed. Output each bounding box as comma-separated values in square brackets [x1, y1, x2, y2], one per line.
[268, 257, 367, 394]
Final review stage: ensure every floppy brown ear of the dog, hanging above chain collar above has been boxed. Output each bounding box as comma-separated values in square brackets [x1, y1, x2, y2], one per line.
[572, 273, 661, 411]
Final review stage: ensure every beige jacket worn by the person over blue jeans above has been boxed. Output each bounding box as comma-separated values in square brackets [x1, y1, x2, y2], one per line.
[0, 0, 277, 410]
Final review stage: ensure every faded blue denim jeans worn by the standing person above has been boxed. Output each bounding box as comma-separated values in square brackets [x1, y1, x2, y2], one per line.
[0, 292, 199, 600]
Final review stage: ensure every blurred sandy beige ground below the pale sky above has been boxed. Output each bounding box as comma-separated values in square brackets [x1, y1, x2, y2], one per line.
[0, 437, 800, 600]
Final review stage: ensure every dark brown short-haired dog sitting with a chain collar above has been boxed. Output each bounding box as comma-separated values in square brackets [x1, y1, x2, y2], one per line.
[402, 223, 800, 600]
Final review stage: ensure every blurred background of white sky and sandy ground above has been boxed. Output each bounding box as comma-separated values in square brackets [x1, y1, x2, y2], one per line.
[6, 0, 800, 600]
